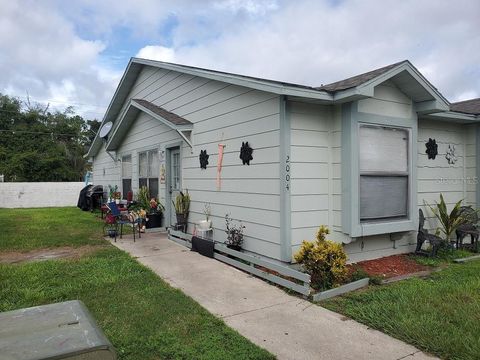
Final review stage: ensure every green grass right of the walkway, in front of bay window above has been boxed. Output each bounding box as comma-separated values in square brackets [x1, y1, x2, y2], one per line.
[322, 261, 480, 360]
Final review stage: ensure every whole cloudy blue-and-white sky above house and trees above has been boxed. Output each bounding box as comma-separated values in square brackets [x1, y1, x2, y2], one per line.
[0, 0, 480, 119]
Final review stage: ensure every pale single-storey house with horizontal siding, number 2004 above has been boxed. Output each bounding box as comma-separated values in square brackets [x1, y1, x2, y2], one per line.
[88, 58, 480, 262]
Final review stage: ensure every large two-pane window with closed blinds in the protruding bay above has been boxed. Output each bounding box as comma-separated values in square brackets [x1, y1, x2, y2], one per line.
[358, 125, 410, 222]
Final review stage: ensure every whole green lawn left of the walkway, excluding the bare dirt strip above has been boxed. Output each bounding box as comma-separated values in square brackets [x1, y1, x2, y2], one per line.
[0, 209, 274, 360]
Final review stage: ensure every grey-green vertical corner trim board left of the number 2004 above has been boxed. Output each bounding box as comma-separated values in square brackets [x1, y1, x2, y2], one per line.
[279, 95, 292, 262]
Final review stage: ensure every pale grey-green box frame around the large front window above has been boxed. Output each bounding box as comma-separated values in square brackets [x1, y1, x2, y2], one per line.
[342, 101, 417, 237]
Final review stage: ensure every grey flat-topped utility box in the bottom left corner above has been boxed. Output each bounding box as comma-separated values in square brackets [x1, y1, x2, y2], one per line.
[0, 300, 117, 360]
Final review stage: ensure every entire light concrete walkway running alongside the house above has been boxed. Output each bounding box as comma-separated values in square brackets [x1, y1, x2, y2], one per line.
[112, 233, 433, 360]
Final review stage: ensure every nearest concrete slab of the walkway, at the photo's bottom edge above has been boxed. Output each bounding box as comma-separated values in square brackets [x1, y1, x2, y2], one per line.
[224, 299, 432, 360]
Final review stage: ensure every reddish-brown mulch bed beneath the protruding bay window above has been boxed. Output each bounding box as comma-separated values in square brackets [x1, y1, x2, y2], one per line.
[355, 255, 431, 279]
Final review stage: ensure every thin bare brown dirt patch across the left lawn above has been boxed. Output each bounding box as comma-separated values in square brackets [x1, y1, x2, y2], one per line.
[0, 245, 105, 264]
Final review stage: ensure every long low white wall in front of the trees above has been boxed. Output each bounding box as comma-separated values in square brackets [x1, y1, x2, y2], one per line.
[0, 182, 85, 208]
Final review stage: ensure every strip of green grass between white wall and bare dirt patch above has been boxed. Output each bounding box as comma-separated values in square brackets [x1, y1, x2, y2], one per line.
[0, 207, 104, 251]
